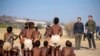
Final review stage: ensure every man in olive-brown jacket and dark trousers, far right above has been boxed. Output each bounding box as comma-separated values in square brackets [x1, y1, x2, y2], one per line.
[85, 15, 96, 49]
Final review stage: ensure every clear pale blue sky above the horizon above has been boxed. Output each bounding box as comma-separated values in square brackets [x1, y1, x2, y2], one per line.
[0, 0, 100, 25]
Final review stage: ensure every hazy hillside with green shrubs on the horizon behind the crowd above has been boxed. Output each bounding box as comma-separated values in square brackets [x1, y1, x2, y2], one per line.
[0, 15, 48, 29]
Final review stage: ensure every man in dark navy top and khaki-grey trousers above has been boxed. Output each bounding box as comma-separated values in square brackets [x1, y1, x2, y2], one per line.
[73, 17, 84, 49]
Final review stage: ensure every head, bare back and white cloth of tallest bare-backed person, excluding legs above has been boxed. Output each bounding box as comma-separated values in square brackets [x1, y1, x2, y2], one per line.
[50, 17, 63, 45]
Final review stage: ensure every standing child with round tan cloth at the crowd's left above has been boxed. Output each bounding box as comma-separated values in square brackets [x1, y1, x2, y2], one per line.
[3, 26, 18, 56]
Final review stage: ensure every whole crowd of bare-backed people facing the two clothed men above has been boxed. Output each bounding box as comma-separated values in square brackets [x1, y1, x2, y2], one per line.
[0, 17, 75, 56]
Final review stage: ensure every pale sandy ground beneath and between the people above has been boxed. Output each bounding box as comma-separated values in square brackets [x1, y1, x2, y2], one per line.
[0, 28, 100, 56]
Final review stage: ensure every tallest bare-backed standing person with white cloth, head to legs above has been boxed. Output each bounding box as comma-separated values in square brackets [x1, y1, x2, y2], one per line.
[49, 17, 63, 56]
